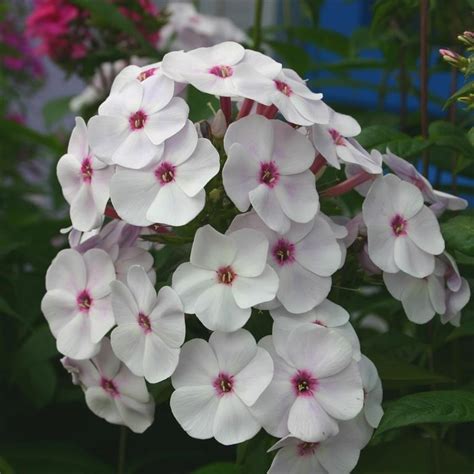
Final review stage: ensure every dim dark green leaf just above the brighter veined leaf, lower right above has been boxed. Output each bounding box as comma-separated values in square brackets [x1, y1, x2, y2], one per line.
[371, 354, 452, 388]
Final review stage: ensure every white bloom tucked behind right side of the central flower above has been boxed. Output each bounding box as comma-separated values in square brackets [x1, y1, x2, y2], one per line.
[229, 212, 342, 313]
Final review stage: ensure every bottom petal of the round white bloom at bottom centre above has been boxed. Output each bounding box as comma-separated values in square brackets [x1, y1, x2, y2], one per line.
[214, 394, 261, 446]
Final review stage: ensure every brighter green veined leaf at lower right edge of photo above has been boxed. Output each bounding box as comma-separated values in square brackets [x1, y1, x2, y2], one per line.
[376, 390, 474, 436]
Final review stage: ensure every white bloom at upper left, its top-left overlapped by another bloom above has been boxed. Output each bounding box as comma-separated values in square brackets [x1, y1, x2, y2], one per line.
[110, 121, 220, 226]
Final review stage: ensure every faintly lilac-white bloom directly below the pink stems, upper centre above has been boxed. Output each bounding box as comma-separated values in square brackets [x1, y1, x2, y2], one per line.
[222, 115, 319, 233]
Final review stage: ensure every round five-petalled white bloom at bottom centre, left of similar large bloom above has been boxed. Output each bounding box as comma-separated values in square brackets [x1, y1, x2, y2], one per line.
[170, 329, 273, 445]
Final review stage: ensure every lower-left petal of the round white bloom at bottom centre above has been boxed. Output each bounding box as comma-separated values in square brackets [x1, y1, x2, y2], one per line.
[170, 385, 219, 439]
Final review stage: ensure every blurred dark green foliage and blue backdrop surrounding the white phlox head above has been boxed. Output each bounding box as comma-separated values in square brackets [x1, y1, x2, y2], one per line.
[0, 0, 474, 474]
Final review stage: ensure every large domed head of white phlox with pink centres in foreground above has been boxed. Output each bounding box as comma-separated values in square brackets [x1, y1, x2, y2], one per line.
[42, 42, 469, 474]
